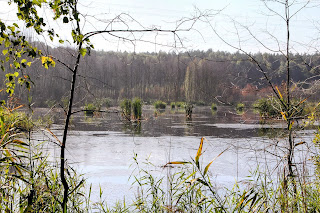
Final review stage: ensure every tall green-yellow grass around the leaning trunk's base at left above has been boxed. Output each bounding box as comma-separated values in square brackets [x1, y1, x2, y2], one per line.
[0, 107, 87, 212]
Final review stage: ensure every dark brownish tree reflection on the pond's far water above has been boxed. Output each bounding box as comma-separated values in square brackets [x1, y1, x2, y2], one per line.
[33, 106, 283, 138]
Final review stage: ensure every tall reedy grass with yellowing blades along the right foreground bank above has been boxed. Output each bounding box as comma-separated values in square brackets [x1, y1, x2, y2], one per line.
[120, 138, 320, 212]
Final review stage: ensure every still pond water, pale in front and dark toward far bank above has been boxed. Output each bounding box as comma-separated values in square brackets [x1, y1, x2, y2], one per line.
[33, 106, 313, 204]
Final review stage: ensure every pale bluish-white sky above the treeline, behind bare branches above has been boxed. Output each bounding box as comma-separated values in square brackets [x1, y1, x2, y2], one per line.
[0, 0, 320, 53]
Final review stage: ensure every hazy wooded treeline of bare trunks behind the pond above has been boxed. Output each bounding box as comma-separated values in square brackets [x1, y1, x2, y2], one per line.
[0, 43, 320, 107]
